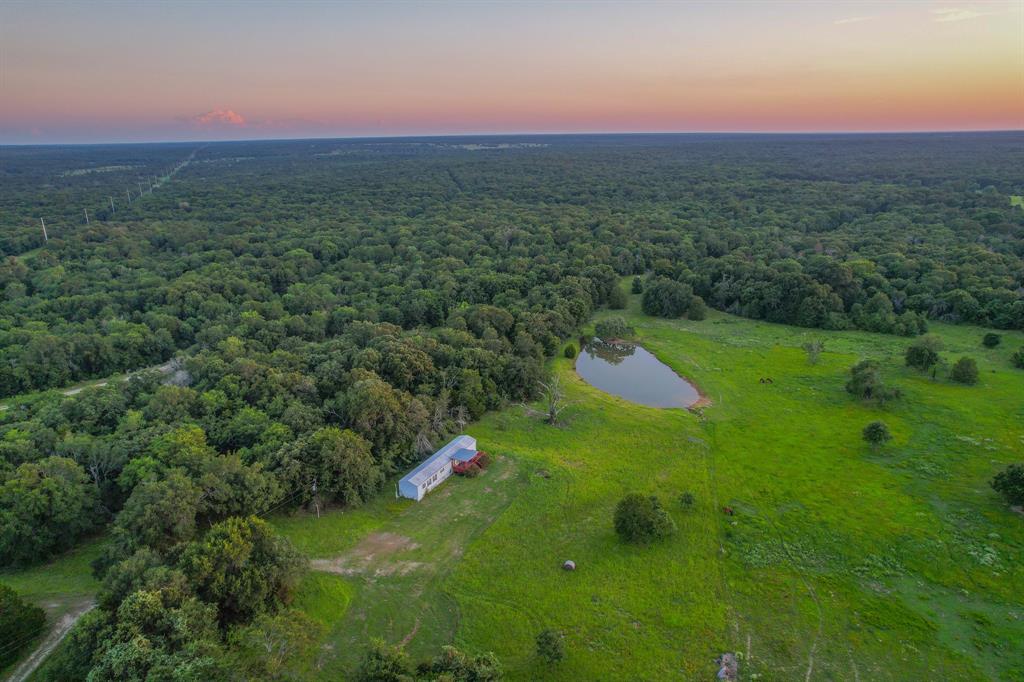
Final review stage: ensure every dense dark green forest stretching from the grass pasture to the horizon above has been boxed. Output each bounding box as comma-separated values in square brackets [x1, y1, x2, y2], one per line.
[0, 133, 1024, 680]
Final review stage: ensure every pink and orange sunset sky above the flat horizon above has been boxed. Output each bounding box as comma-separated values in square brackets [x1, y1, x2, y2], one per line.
[0, 0, 1024, 143]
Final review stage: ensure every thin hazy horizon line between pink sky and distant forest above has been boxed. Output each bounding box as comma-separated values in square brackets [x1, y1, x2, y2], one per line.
[0, 127, 1024, 147]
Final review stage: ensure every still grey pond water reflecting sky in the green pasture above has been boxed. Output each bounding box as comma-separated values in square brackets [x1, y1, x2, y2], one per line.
[577, 338, 700, 408]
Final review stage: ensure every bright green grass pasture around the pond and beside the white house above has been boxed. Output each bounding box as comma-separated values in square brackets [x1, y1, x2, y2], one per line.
[0, 284, 1024, 680]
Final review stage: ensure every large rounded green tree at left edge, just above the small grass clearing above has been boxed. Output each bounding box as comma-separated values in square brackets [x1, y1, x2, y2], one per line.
[0, 457, 102, 564]
